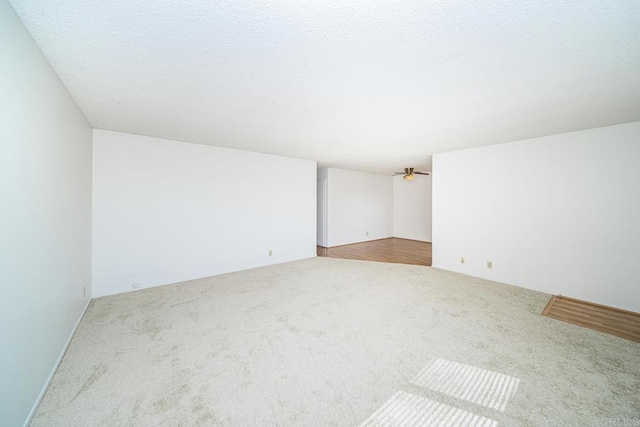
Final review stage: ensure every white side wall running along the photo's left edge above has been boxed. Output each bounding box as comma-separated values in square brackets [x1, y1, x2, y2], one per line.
[0, 0, 91, 426]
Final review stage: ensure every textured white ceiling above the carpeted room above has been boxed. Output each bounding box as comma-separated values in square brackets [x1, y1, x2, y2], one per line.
[11, 0, 640, 173]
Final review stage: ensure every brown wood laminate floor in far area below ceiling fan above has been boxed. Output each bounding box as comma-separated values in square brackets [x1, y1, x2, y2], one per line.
[318, 237, 431, 266]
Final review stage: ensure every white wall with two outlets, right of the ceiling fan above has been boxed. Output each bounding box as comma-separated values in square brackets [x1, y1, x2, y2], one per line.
[433, 122, 640, 312]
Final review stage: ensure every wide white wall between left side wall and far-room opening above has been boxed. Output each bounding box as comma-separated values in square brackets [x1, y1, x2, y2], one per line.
[93, 130, 316, 296]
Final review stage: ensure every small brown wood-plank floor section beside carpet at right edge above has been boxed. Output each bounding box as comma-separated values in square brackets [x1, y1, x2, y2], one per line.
[542, 295, 640, 342]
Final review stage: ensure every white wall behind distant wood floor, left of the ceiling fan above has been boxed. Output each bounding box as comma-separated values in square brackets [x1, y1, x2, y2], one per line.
[327, 168, 393, 247]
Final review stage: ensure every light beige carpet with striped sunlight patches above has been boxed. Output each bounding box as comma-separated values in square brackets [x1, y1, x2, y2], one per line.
[32, 258, 640, 426]
